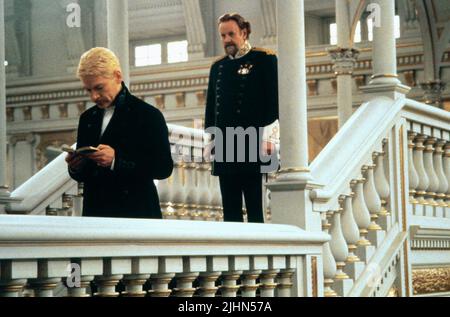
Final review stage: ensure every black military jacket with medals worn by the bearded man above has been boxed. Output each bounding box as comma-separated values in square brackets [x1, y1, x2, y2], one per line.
[205, 48, 279, 175]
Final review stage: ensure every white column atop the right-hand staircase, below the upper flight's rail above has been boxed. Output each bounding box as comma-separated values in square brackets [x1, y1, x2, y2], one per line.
[370, 0, 400, 85]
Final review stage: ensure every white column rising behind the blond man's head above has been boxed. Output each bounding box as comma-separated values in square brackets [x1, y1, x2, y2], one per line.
[106, 0, 130, 85]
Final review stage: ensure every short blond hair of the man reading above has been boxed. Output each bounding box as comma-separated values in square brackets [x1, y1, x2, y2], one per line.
[77, 47, 122, 78]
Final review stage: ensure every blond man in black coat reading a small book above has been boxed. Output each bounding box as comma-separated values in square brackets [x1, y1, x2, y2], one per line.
[66, 48, 173, 219]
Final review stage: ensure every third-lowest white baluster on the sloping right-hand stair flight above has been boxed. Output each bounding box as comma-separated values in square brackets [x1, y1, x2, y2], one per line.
[341, 193, 360, 263]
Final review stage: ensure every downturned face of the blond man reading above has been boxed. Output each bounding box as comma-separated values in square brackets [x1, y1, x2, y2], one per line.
[81, 71, 122, 109]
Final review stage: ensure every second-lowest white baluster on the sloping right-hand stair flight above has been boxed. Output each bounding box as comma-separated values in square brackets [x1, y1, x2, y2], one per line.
[330, 201, 349, 280]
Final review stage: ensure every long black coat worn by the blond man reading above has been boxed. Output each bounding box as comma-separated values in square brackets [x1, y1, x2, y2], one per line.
[69, 85, 173, 219]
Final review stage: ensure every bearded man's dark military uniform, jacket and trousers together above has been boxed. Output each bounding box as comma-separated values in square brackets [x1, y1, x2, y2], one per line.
[205, 48, 278, 222]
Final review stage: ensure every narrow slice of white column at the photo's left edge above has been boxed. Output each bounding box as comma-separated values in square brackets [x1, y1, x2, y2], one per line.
[0, 0, 9, 196]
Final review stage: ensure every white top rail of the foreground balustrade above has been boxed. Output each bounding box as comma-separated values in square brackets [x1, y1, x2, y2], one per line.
[0, 215, 329, 259]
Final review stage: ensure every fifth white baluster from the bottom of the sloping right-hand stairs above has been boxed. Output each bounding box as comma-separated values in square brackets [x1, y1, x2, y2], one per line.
[363, 165, 381, 231]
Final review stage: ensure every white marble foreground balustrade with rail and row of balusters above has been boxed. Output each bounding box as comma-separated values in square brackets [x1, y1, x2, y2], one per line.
[0, 215, 329, 297]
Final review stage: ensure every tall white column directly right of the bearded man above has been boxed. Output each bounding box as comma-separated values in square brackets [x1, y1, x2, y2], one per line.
[277, 0, 310, 181]
